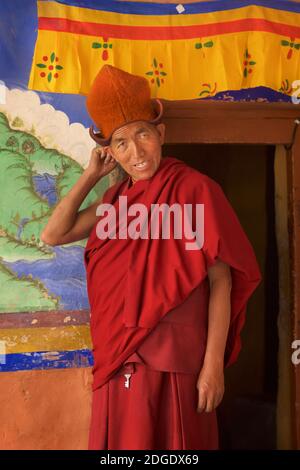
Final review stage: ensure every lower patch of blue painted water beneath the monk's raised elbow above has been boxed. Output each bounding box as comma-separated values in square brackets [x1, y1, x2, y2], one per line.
[3, 246, 89, 310]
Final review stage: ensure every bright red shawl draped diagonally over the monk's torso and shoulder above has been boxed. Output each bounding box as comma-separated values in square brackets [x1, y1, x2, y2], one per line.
[84, 157, 261, 390]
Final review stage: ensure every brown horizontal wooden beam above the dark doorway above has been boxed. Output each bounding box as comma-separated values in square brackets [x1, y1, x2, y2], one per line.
[162, 100, 300, 145]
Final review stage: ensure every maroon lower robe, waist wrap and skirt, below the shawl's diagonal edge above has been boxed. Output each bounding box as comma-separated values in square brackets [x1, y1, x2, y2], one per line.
[89, 282, 218, 450]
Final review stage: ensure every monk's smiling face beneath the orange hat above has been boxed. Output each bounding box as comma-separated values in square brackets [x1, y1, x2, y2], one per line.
[110, 121, 165, 182]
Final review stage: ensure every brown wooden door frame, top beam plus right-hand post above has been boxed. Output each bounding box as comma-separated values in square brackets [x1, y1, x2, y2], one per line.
[162, 100, 300, 449]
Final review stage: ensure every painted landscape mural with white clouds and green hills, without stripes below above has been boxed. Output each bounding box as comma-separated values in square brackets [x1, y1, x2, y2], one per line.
[0, 90, 107, 312]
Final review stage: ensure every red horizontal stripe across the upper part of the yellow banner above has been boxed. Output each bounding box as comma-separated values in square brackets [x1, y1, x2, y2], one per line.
[39, 17, 300, 40]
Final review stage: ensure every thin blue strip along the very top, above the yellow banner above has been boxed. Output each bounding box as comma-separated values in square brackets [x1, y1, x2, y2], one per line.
[53, 0, 300, 15]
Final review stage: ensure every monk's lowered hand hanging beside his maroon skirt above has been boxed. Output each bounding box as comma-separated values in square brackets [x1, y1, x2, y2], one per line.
[197, 364, 224, 413]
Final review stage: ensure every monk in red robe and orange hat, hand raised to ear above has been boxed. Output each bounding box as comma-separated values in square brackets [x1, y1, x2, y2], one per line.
[41, 65, 261, 450]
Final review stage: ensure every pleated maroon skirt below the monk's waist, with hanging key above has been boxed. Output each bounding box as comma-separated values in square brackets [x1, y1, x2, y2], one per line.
[89, 362, 218, 450]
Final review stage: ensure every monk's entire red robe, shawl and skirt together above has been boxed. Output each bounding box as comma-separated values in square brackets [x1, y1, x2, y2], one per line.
[85, 157, 260, 449]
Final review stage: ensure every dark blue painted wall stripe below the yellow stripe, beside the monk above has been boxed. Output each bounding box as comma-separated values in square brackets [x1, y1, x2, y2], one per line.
[0, 349, 94, 372]
